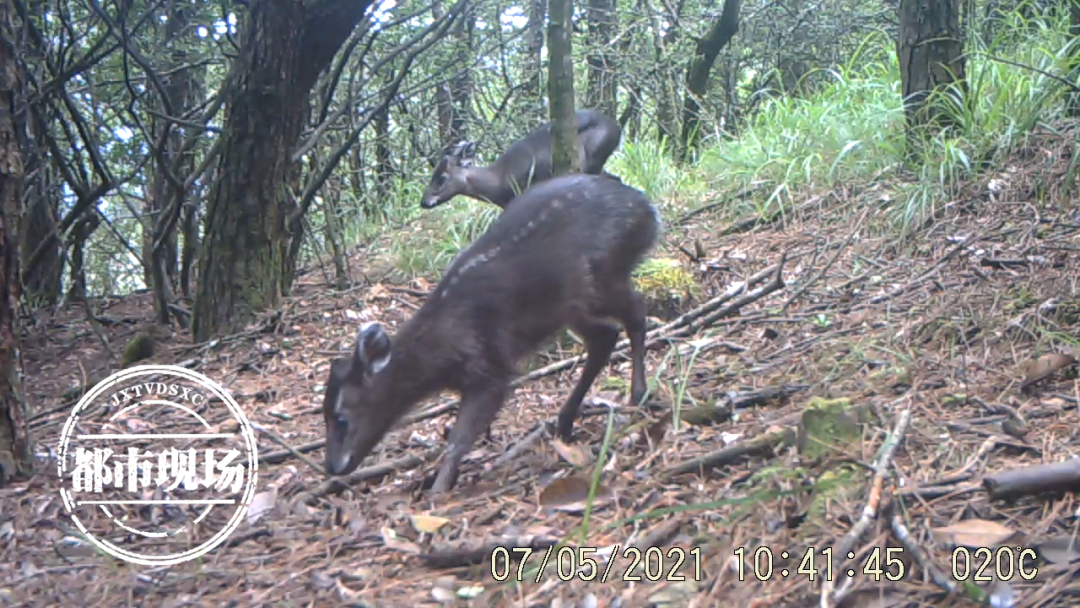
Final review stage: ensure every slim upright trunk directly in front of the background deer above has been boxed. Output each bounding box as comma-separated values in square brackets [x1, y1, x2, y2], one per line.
[548, 0, 581, 175]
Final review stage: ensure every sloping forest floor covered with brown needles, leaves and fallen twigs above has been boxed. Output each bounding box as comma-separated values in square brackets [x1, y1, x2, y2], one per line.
[0, 121, 1080, 608]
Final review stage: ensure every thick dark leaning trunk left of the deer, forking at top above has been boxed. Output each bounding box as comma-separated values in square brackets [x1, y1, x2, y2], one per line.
[191, 0, 370, 341]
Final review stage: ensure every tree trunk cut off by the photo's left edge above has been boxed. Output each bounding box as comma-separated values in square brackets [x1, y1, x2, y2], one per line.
[0, 0, 33, 485]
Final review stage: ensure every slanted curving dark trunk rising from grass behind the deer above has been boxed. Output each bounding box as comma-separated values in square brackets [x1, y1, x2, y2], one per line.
[678, 0, 740, 161]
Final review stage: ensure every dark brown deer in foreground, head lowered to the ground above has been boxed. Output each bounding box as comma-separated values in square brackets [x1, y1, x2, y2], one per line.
[323, 174, 661, 494]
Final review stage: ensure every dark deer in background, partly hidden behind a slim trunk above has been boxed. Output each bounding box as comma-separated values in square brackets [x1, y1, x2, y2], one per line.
[420, 110, 622, 210]
